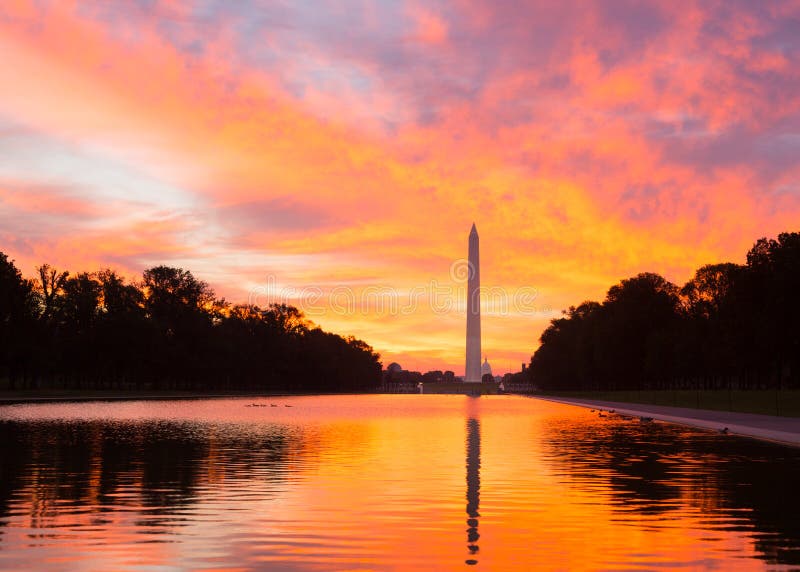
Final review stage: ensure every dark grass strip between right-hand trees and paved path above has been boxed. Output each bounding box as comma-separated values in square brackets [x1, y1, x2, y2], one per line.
[543, 390, 800, 417]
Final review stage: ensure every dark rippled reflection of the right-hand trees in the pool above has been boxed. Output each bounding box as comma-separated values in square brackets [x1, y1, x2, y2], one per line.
[542, 416, 800, 566]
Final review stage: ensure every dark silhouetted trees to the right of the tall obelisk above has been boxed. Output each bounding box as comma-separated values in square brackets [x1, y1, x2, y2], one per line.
[528, 233, 800, 390]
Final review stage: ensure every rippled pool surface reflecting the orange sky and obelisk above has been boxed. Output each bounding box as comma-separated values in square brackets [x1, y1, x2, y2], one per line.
[0, 395, 800, 571]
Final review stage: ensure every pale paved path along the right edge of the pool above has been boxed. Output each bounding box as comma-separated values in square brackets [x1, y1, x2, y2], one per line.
[536, 396, 800, 446]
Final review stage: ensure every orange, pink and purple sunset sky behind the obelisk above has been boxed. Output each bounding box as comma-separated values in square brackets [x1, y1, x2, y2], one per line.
[0, 0, 800, 375]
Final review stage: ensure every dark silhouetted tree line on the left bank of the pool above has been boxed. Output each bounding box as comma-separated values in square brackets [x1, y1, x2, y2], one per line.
[0, 252, 381, 392]
